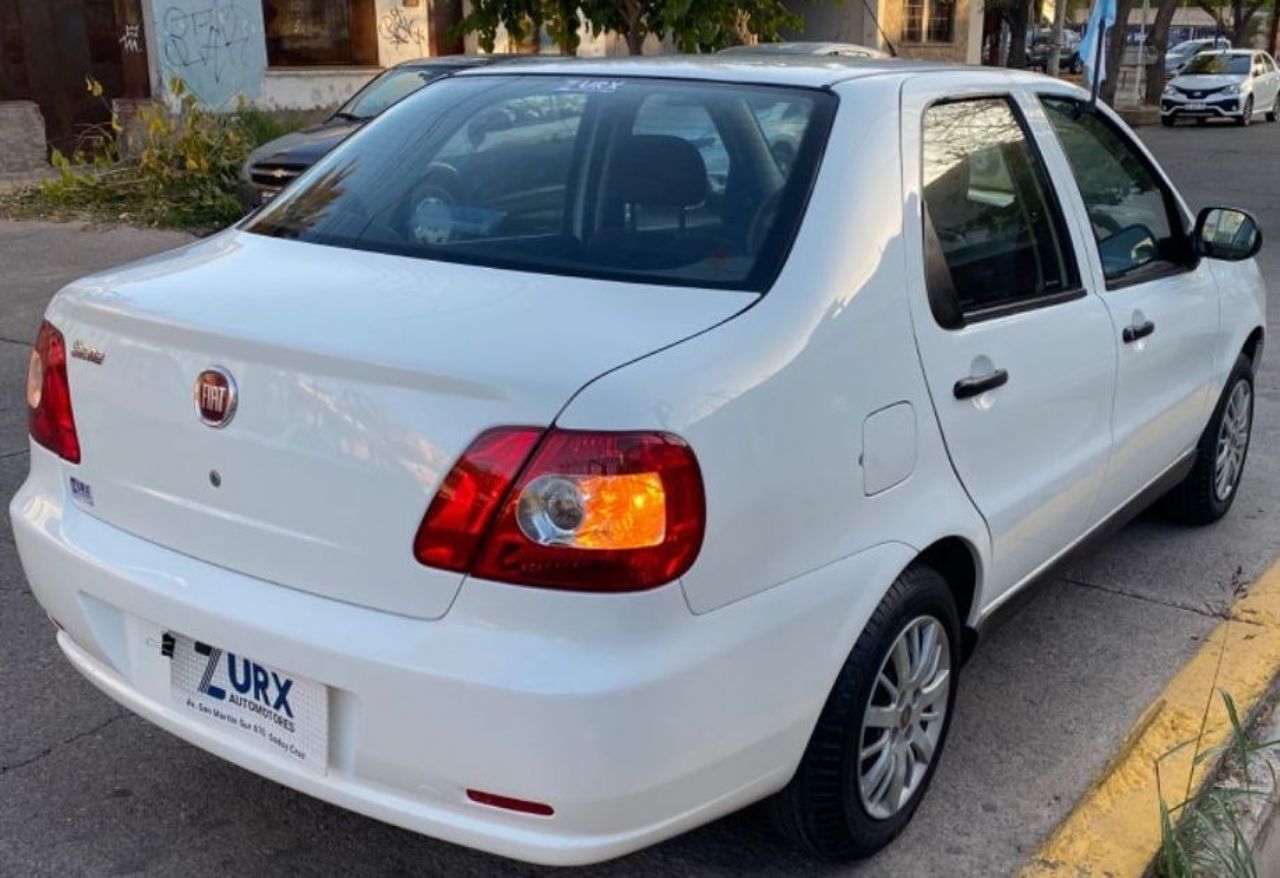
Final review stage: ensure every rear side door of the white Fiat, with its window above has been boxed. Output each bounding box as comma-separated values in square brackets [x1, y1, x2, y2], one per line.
[904, 84, 1115, 599]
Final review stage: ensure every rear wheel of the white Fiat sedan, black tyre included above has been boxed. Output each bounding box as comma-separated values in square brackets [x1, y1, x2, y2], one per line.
[769, 564, 960, 860]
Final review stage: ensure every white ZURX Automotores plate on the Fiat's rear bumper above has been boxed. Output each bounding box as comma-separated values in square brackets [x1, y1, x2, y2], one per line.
[166, 635, 329, 774]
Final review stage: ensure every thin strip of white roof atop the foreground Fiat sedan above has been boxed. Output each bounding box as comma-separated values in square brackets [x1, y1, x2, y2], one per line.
[458, 52, 1046, 88]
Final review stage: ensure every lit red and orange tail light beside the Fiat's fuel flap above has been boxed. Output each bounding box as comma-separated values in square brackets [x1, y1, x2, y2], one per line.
[413, 427, 707, 591]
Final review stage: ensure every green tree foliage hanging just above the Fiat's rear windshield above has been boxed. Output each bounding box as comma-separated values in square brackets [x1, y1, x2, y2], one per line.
[460, 0, 801, 55]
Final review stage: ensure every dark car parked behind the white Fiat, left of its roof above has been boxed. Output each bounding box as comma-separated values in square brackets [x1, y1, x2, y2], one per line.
[239, 55, 509, 210]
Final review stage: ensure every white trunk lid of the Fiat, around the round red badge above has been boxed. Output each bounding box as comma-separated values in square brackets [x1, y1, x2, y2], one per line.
[49, 232, 755, 618]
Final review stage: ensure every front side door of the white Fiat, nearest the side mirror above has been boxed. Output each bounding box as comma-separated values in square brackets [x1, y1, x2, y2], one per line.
[1041, 95, 1219, 517]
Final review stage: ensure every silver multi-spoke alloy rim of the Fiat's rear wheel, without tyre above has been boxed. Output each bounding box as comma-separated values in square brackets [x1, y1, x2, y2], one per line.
[858, 616, 951, 820]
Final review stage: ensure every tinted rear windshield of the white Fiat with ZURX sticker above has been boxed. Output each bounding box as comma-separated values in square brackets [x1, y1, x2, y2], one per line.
[244, 74, 835, 291]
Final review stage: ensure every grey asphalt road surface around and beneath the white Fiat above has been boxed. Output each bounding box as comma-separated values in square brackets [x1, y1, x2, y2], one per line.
[0, 118, 1280, 878]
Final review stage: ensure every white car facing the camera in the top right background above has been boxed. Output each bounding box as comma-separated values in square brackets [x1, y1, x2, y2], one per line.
[1160, 49, 1280, 127]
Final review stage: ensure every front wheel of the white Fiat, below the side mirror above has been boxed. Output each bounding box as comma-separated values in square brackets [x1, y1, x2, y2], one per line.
[1167, 356, 1253, 525]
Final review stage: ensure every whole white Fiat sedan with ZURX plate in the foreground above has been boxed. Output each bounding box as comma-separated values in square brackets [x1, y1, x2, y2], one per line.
[10, 58, 1265, 864]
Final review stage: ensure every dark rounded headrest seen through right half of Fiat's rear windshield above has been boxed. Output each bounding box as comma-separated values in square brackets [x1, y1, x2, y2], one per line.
[609, 134, 707, 207]
